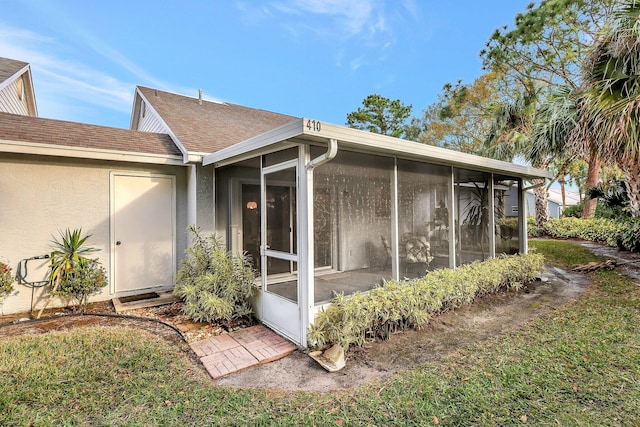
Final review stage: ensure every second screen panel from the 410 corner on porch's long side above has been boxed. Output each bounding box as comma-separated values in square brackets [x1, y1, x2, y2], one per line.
[398, 159, 451, 277]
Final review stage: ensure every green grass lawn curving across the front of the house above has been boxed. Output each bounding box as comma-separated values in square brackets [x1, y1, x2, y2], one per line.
[0, 241, 640, 426]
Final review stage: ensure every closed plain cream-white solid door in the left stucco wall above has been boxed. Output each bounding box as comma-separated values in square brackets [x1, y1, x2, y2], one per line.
[111, 173, 176, 296]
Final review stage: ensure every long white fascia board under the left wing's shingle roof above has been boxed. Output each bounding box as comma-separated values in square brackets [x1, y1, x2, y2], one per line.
[0, 140, 184, 166]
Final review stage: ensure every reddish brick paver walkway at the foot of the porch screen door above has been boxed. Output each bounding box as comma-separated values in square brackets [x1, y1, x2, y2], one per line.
[191, 325, 296, 379]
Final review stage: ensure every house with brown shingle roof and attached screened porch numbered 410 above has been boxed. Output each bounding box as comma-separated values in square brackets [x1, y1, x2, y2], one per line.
[0, 58, 548, 345]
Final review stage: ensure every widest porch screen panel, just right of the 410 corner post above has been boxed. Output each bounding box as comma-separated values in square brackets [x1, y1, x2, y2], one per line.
[313, 150, 393, 304]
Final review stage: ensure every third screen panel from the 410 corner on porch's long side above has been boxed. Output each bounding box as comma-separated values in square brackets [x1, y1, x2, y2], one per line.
[454, 169, 493, 265]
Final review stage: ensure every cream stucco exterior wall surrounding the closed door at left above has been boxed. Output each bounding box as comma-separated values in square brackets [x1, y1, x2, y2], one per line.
[0, 154, 188, 314]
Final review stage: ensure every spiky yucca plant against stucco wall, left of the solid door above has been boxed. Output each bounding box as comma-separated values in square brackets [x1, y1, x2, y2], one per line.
[36, 228, 99, 319]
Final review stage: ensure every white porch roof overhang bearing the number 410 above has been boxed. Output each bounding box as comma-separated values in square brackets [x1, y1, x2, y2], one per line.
[202, 118, 552, 179]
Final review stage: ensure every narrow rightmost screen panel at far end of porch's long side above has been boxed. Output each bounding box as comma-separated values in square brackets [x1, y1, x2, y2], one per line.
[493, 176, 520, 255]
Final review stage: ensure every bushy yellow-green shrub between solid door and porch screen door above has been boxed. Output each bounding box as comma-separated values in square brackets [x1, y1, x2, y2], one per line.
[173, 226, 255, 322]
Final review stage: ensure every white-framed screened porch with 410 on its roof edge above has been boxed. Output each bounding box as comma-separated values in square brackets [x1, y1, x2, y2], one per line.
[203, 118, 549, 346]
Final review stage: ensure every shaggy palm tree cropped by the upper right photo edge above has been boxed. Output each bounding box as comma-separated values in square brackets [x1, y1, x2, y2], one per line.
[579, 0, 640, 217]
